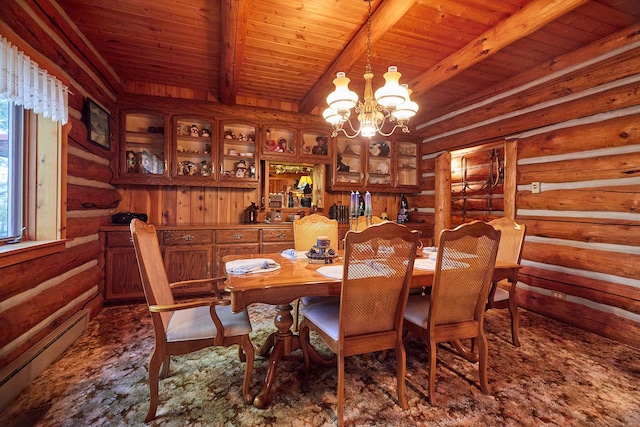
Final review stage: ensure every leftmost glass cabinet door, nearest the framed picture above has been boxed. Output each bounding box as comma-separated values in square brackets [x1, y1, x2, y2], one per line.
[120, 112, 168, 180]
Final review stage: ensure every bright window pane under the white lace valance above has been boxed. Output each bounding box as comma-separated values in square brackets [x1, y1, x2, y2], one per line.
[0, 100, 24, 240]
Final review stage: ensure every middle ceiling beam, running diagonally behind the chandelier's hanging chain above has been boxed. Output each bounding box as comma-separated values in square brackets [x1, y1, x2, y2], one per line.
[298, 0, 417, 114]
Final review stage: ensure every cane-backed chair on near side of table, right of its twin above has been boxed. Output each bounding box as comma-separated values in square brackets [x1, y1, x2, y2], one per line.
[404, 221, 500, 405]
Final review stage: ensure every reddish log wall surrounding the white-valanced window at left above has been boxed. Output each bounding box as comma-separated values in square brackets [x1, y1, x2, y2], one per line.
[0, 0, 120, 370]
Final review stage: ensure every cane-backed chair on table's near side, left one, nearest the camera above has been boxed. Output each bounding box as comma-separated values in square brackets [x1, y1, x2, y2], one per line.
[300, 222, 420, 425]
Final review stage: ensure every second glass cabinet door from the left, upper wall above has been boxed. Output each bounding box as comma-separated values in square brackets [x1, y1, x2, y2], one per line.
[172, 116, 217, 181]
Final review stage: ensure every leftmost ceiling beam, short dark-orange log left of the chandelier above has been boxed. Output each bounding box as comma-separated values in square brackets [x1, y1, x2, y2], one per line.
[218, 0, 249, 106]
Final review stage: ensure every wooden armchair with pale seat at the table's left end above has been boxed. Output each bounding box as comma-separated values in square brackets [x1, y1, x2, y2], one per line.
[130, 219, 254, 422]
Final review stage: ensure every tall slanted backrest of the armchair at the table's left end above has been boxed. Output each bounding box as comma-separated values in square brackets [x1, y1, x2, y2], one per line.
[129, 219, 175, 330]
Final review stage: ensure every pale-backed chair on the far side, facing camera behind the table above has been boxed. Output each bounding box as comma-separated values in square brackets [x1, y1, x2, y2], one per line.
[293, 214, 339, 332]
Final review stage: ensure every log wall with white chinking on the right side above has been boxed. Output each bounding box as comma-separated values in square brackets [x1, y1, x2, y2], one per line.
[419, 25, 640, 347]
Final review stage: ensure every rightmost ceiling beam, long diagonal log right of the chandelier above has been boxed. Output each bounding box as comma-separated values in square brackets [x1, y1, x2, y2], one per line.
[409, 0, 589, 99]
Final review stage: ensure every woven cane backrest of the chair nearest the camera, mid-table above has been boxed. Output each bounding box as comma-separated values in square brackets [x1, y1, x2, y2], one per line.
[340, 222, 420, 341]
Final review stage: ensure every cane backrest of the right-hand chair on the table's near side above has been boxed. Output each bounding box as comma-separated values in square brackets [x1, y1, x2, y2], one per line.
[429, 221, 500, 328]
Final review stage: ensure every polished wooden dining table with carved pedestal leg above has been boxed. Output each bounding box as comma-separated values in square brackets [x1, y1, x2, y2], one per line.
[222, 252, 520, 408]
